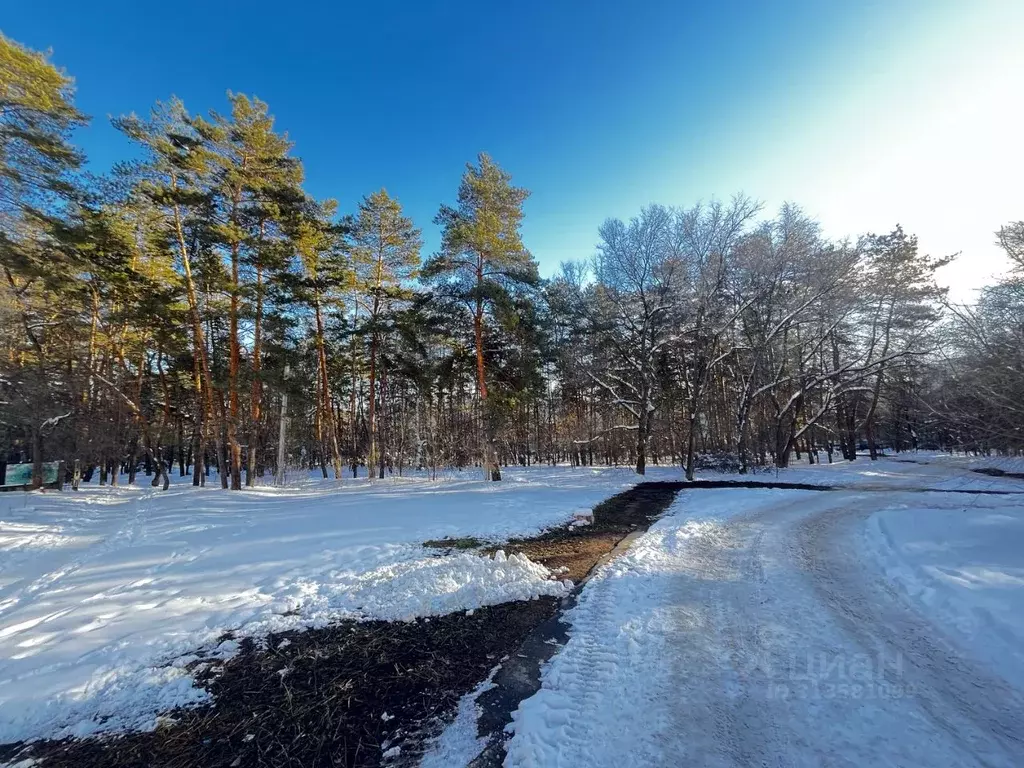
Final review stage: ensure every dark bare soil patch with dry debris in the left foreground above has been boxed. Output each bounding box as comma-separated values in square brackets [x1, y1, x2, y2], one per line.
[0, 598, 558, 768]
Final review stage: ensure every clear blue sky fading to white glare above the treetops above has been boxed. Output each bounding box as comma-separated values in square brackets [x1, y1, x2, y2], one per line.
[0, 0, 1024, 298]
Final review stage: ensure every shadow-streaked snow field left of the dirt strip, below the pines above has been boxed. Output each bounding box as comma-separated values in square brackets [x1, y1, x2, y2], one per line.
[0, 467, 678, 743]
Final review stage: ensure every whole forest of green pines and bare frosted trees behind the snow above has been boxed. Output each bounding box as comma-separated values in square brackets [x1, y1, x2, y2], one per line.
[0, 31, 1024, 489]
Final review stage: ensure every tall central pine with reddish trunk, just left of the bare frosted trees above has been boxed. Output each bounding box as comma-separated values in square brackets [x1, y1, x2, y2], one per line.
[423, 153, 539, 480]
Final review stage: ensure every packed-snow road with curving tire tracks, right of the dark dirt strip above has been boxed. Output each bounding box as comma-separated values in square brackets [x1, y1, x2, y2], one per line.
[506, 488, 1024, 768]
